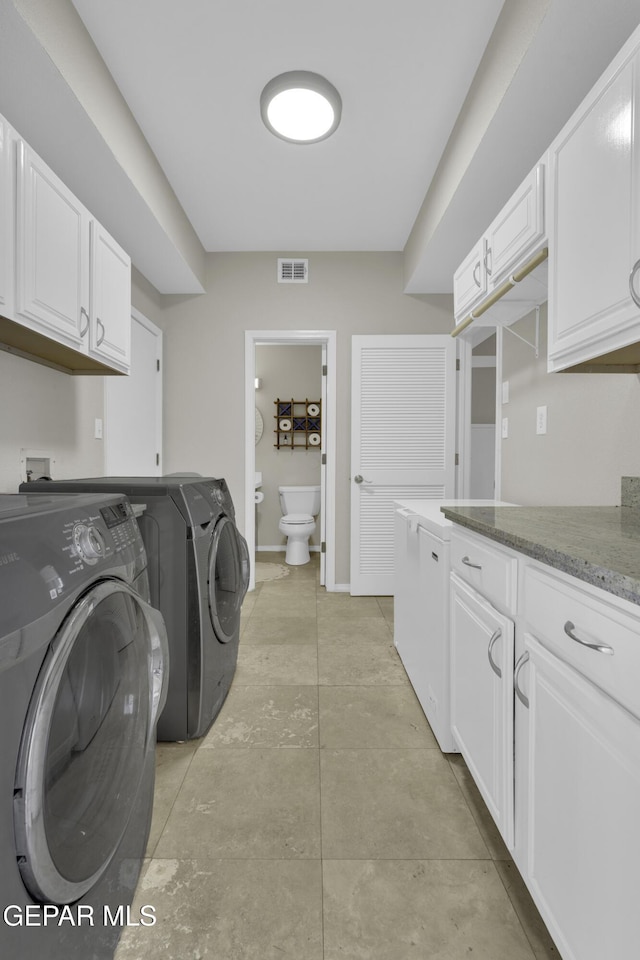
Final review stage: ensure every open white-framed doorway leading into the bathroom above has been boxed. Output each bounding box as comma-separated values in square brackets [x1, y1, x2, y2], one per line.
[245, 330, 336, 590]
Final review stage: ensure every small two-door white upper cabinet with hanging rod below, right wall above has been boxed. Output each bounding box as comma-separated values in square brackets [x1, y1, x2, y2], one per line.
[453, 160, 546, 324]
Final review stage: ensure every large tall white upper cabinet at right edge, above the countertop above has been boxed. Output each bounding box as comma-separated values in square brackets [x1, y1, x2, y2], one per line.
[549, 30, 640, 371]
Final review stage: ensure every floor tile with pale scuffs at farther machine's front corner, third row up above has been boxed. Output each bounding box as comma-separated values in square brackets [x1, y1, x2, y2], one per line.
[201, 684, 318, 750]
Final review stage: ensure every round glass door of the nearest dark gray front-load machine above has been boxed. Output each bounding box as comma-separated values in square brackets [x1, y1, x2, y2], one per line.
[14, 580, 167, 904]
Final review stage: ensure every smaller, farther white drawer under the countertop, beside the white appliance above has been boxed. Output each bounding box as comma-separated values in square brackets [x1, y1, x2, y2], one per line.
[451, 528, 518, 613]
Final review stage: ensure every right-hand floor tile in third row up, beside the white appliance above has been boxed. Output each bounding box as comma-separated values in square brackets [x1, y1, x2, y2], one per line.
[319, 684, 439, 749]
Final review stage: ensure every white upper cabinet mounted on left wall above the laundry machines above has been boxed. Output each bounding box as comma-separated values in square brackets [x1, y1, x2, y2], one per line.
[0, 117, 131, 374]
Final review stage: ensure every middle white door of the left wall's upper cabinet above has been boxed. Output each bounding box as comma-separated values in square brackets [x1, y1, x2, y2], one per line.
[16, 140, 89, 351]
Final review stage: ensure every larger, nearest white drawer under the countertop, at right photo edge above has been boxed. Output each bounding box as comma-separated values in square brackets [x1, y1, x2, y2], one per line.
[523, 564, 640, 717]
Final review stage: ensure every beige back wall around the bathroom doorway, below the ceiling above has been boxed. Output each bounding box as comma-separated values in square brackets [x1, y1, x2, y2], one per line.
[151, 251, 453, 583]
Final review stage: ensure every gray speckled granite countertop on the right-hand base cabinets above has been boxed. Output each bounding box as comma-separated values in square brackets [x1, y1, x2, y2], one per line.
[442, 504, 640, 604]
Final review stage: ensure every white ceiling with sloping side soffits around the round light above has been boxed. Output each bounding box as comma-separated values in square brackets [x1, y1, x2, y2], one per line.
[0, 0, 640, 294]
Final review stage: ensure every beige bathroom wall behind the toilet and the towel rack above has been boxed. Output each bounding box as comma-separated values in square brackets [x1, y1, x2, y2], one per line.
[256, 344, 322, 547]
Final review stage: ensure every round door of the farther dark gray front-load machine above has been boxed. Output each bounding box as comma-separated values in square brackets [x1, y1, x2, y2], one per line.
[208, 517, 246, 643]
